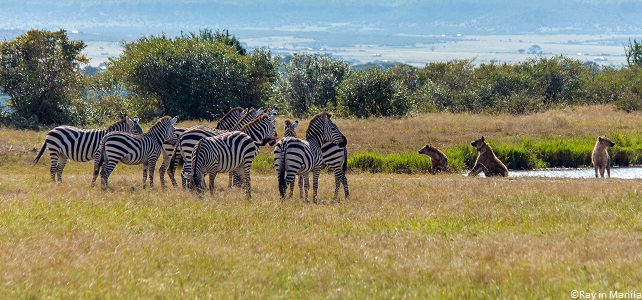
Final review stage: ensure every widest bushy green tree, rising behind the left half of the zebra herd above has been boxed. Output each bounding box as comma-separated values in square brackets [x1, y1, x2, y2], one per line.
[108, 30, 277, 119]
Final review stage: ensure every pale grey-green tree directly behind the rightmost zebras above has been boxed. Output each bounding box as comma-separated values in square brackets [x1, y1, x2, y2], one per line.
[277, 53, 350, 116]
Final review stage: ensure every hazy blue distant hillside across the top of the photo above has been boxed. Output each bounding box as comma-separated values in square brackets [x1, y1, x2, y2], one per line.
[0, 0, 642, 36]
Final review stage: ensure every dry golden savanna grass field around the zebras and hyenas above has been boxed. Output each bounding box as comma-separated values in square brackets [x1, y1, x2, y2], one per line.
[0, 106, 642, 299]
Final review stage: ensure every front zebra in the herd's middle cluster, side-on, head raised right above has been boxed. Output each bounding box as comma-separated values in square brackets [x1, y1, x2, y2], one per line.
[185, 114, 276, 198]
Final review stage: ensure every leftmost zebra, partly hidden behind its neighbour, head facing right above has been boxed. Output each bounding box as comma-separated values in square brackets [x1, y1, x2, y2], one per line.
[33, 117, 143, 182]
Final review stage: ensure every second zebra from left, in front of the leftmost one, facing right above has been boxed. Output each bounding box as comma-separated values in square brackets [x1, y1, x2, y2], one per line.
[91, 116, 176, 189]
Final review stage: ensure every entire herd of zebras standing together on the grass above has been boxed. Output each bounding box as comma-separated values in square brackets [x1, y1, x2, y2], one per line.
[34, 107, 349, 202]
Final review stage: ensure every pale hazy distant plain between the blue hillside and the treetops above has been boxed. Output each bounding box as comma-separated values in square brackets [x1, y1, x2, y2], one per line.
[81, 30, 637, 67]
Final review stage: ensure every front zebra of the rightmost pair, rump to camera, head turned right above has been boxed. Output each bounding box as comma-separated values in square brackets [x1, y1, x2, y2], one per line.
[274, 112, 347, 202]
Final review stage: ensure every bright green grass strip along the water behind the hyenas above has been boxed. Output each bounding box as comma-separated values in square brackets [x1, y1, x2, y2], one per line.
[254, 133, 642, 174]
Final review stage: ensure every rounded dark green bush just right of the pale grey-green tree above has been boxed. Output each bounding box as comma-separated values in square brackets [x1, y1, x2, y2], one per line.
[337, 69, 413, 118]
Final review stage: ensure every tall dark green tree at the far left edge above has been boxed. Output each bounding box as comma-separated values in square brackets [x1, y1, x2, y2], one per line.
[0, 29, 88, 125]
